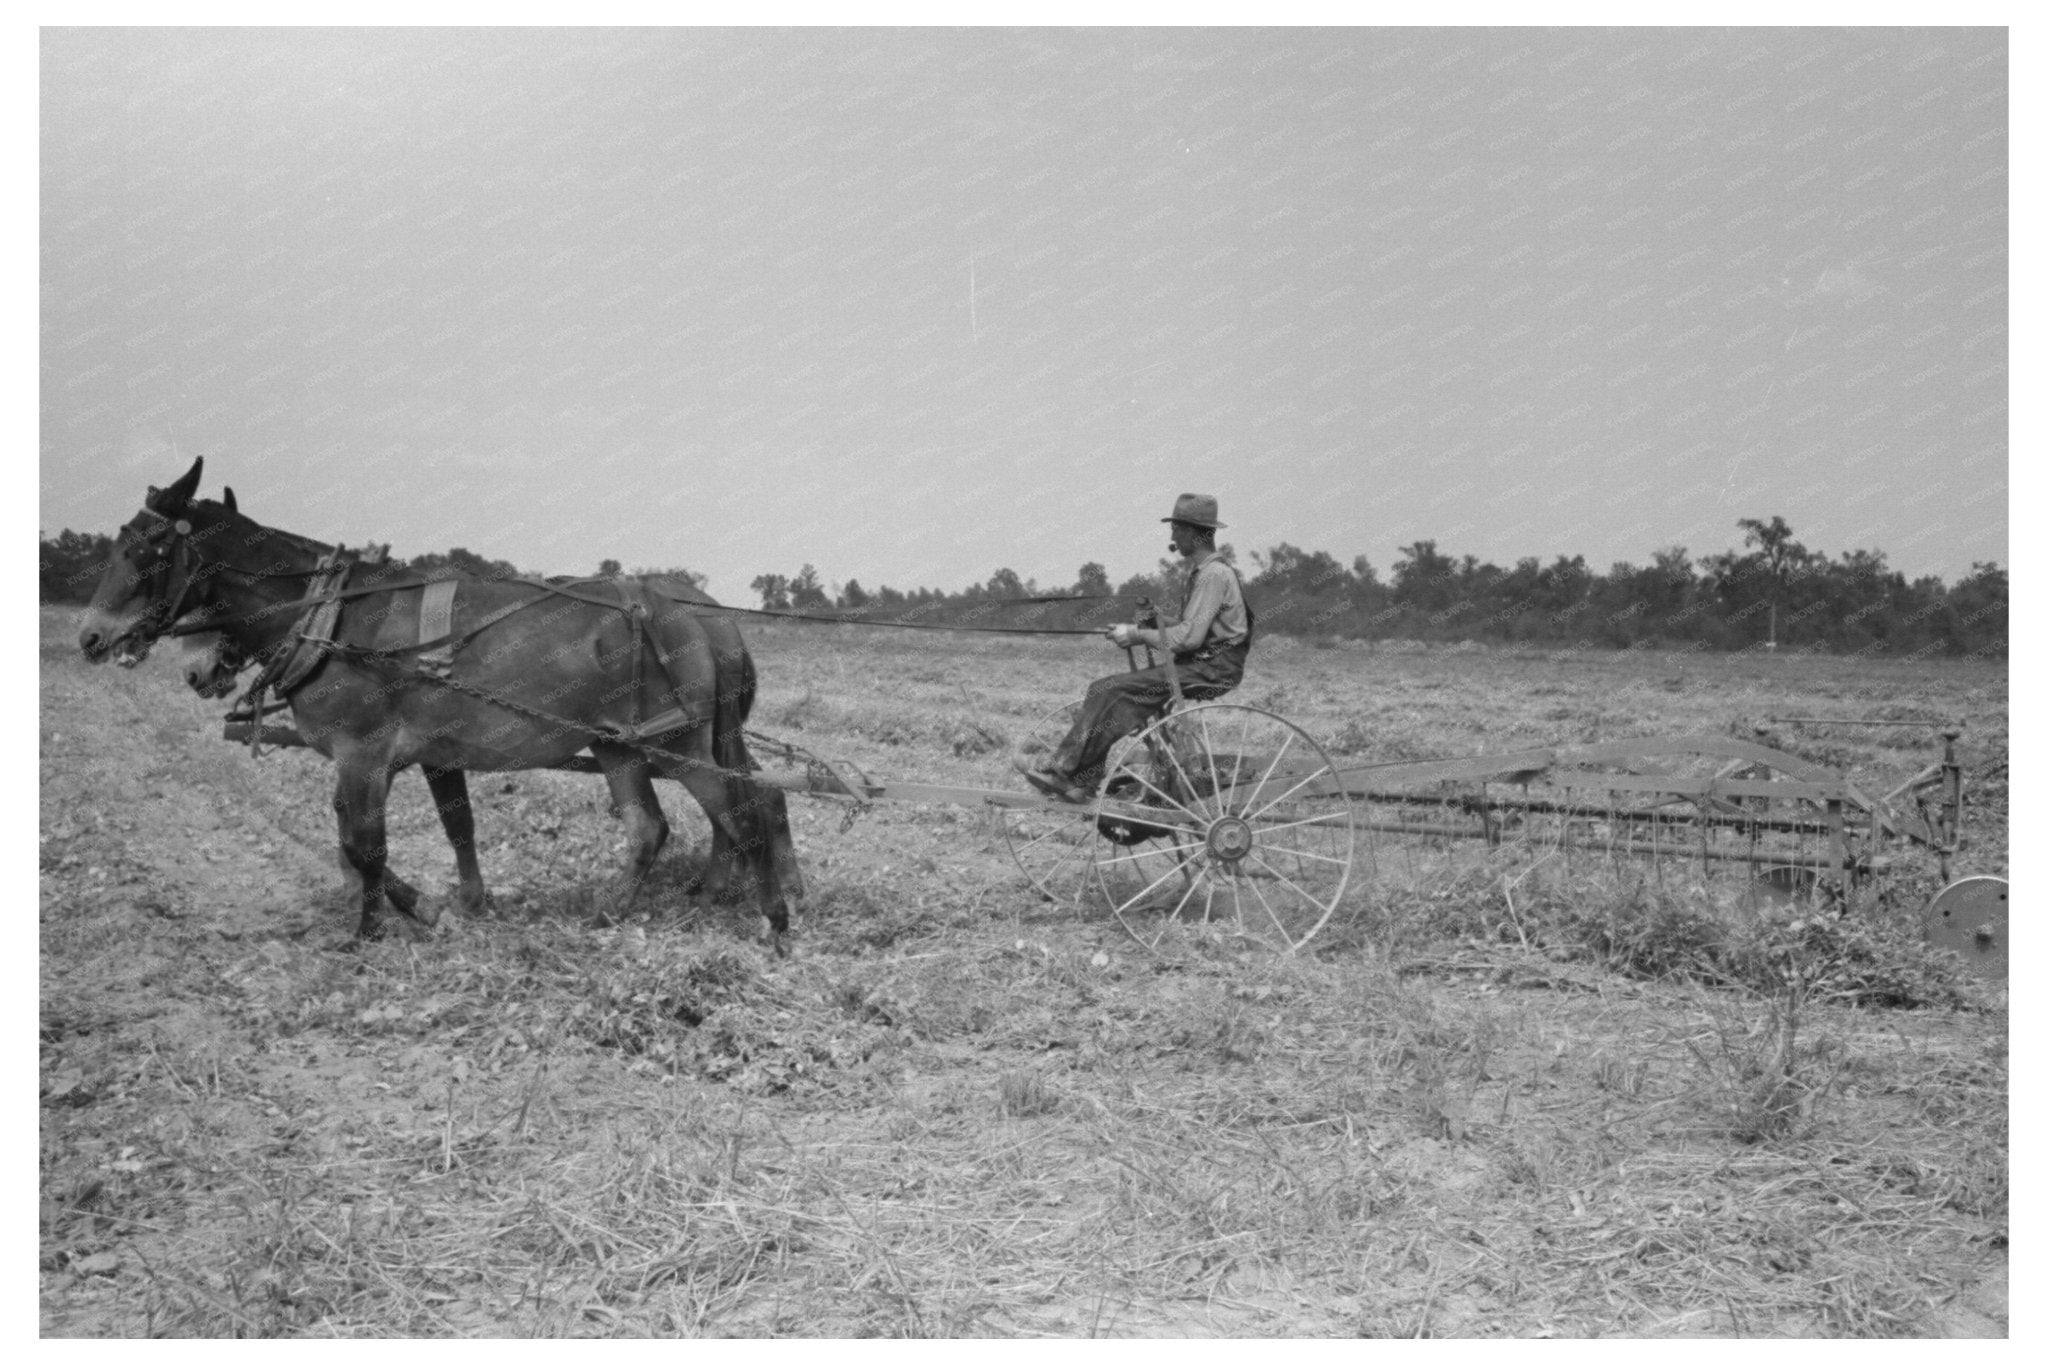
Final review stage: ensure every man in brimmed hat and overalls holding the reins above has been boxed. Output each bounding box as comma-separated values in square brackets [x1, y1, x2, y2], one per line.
[1016, 493, 1251, 802]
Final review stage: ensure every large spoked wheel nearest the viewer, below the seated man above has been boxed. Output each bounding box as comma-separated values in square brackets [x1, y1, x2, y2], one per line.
[1085, 702, 1356, 952]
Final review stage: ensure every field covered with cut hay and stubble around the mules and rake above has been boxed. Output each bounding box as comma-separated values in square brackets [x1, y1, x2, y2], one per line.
[39, 608, 2007, 1336]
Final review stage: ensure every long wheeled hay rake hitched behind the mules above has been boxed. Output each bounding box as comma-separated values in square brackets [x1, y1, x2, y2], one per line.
[225, 702, 2007, 976]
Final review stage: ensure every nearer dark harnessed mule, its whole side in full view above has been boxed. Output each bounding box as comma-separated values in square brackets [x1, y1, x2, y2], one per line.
[78, 460, 803, 945]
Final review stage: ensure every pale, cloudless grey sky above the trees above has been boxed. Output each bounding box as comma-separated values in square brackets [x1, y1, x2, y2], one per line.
[39, 29, 2009, 602]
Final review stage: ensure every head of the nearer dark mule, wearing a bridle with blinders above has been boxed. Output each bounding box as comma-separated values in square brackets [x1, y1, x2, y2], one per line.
[78, 458, 238, 667]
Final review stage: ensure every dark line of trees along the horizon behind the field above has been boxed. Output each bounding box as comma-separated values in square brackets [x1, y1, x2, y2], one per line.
[41, 516, 2009, 657]
